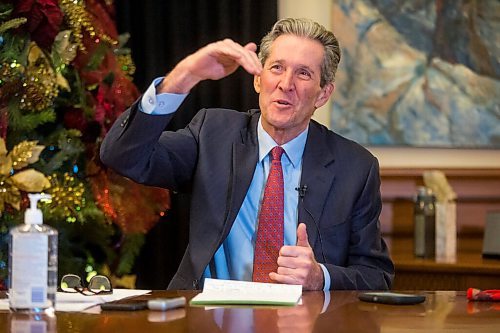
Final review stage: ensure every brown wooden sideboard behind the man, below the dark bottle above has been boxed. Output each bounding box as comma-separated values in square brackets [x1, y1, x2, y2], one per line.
[388, 237, 500, 291]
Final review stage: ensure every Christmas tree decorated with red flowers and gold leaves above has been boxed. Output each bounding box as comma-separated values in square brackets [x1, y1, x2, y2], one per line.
[0, 0, 169, 288]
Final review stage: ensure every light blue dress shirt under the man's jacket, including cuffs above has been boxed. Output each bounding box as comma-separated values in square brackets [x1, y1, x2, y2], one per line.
[140, 78, 330, 290]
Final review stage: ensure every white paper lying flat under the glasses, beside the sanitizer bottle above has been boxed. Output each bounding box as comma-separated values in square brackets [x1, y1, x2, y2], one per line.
[0, 289, 151, 312]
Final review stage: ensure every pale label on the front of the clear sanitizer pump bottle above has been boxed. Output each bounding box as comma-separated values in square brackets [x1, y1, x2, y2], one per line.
[9, 234, 49, 308]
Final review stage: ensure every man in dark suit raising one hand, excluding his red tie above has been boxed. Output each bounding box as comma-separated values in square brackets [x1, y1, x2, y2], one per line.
[101, 19, 394, 290]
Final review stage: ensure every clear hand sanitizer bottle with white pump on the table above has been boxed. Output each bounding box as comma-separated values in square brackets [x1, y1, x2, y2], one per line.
[9, 193, 57, 313]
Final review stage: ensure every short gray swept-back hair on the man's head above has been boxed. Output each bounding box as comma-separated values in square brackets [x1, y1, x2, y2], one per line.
[259, 18, 340, 87]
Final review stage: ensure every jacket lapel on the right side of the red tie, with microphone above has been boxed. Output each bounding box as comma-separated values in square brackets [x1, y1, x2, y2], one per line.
[299, 122, 335, 250]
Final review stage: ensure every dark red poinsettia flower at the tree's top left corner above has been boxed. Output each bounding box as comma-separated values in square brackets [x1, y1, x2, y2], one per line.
[14, 0, 63, 49]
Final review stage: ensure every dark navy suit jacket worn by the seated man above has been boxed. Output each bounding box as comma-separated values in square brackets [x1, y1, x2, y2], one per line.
[101, 104, 394, 289]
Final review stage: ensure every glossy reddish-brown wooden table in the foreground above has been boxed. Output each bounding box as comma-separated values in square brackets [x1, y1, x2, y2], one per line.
[0, 291, 500, 333]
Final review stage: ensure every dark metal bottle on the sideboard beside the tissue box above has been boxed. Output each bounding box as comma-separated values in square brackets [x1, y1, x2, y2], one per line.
[413, 186, 436, 258]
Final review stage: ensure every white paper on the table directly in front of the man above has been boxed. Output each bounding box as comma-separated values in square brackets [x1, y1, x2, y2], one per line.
[190, 279, 302, 305]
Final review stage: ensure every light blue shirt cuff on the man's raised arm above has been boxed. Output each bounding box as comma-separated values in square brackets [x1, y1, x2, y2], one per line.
[139, 77, 188, 115]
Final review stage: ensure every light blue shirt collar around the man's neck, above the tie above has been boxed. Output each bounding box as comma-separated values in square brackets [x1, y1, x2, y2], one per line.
[257, 117, 309, 168]
